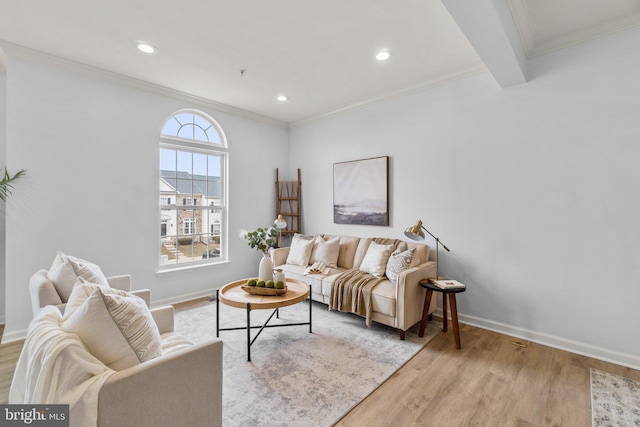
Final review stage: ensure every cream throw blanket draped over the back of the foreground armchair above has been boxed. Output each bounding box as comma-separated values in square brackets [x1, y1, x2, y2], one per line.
[9, 306, 115, 427]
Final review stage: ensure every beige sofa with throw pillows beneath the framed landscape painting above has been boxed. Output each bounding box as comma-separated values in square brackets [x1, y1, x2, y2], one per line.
[270, 234, 436, 340]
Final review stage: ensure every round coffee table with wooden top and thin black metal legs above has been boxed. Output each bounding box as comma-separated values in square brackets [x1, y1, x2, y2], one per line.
[216, 279, 312, 362]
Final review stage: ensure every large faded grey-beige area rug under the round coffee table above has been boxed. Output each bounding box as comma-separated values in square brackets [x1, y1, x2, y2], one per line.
[175, 301, 442, 427]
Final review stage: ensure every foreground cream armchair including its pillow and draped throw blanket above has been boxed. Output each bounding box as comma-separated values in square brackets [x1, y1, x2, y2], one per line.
[16, 279, 223, 427]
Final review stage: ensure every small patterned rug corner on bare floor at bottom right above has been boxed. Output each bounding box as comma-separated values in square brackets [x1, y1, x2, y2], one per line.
[591, 369, 640, 427]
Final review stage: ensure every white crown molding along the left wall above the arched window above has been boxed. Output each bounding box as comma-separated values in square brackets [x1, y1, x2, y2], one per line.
[0, 39, 288, 128]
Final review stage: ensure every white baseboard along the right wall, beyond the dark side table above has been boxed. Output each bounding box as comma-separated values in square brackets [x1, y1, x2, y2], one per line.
[434, 308, 640, 370]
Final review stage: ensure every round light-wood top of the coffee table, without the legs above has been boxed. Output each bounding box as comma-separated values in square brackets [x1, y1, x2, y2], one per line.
[218, 279, 309, 310]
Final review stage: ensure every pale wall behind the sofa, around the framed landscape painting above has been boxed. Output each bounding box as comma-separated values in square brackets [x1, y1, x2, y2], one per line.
[290, 29, 640, 367]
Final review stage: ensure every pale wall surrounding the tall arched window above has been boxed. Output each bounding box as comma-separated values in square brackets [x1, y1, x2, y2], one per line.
[4, 53, 288, 340]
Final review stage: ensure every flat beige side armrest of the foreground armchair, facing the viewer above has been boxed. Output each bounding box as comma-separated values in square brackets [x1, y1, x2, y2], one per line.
[97, 339, 222, 427]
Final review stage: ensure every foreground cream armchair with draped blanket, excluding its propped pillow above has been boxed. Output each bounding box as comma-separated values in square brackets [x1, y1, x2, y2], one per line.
[9, 306, 223, 427]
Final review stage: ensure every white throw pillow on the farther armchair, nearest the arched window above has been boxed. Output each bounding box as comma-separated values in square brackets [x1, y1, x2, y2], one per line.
[47, 251, 109, 302]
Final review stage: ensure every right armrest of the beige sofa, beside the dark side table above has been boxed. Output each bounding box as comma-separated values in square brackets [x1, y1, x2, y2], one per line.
[396, 261, 436, 331]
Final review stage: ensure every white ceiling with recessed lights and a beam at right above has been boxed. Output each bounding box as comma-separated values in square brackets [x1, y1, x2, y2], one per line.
[0, 0, 640, 124]
